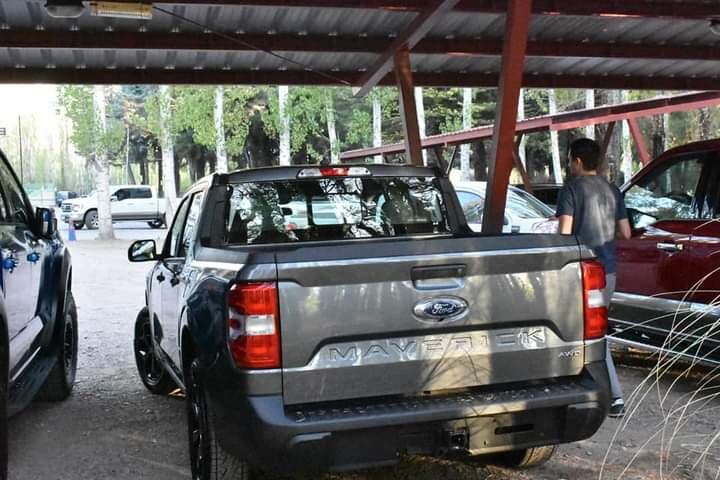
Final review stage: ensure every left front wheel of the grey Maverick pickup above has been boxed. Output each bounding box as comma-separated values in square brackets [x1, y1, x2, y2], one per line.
[134, 308, 177, 395]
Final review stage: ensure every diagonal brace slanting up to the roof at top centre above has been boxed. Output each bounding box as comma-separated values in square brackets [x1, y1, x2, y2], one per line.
[356, 0, 460, 97]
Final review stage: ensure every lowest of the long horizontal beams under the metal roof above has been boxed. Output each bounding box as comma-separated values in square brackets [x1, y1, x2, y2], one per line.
[0, 68, 720, 91]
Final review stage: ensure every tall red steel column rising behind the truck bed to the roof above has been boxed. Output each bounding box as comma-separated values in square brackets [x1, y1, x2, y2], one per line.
[482, 0, 532, 234]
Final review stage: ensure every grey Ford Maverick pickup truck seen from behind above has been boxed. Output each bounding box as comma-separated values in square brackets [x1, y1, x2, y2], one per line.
[128, 165, 608, 479]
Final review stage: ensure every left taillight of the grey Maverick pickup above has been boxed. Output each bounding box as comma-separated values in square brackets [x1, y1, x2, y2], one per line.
[228, 282, 280, 368]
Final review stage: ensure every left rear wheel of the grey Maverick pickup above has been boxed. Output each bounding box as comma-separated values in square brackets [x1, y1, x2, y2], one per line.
[185, 359, 251, 480]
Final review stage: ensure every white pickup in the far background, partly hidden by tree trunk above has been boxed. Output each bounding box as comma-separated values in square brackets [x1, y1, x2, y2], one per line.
[61, 185, 165, 230]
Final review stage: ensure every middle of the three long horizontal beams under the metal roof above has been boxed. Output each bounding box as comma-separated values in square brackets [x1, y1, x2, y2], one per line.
[5, 30, 720, 61]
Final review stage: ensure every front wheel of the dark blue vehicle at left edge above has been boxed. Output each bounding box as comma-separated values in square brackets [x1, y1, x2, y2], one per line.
[40, 292, 78, 402]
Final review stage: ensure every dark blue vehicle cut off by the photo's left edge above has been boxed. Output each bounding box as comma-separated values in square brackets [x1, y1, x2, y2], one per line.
[0, 152, 77, 476]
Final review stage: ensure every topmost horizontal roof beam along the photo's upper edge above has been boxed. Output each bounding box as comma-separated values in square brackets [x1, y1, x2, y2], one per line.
[104, 0, 720, 19]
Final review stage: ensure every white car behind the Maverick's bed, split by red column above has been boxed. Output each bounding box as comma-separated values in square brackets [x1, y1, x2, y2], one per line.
[454, 182, 558, 233]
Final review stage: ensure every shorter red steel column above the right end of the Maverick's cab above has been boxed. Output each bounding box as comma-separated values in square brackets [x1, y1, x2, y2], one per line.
[395, 47, 423, 166]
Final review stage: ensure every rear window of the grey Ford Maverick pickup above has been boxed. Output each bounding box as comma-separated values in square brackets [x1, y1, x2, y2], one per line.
[225, 177, 449, 245]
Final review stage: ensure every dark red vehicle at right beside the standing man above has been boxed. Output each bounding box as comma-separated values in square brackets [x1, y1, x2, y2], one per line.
[610, 140, 720, 364]
